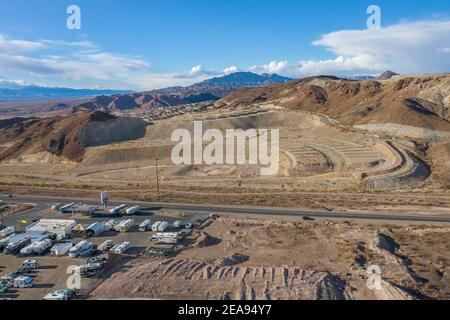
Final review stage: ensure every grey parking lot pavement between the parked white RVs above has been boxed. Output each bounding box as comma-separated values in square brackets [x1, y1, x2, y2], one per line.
[0, 202, 209, 300]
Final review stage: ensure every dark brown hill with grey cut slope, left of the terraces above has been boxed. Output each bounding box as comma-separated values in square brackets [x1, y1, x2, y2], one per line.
[0, 111, 146, 161]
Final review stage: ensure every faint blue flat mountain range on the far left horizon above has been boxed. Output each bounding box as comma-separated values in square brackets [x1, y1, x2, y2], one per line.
[0, 86, 130, 101]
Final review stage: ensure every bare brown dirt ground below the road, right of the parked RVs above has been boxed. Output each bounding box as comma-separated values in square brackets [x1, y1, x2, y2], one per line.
[91, 217, 450, 299]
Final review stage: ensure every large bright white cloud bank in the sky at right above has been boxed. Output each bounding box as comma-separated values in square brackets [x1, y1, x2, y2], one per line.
[310, 20, 450, 73]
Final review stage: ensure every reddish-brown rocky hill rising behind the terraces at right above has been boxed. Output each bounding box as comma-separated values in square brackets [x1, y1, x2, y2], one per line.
[216, 74, 450, 131]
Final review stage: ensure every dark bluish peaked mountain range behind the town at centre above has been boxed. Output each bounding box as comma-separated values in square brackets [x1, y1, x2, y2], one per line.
[77, 72, 293, 112]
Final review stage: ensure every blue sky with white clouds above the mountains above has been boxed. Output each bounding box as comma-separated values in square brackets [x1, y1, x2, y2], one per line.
[0, 0, 450, 90]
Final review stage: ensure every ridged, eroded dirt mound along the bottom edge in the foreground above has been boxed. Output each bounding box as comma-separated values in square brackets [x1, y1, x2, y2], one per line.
[91, 259, 352, 300]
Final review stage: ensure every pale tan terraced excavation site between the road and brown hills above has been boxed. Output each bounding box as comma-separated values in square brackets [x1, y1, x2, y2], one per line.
[0, 104, 450, 213]
